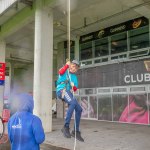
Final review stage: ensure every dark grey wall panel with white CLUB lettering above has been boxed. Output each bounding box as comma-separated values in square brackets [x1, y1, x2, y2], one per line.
[78, 59, 150, 88]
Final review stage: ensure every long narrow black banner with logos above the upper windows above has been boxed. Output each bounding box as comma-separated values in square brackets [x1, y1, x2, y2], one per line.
[80, 17, 149, 43]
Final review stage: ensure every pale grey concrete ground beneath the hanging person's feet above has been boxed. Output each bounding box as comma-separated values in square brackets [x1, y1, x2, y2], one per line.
[45, 119, 150, 150]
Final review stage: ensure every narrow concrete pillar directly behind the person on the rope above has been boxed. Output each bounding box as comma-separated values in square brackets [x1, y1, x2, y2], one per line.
[56, 42, 66, 118]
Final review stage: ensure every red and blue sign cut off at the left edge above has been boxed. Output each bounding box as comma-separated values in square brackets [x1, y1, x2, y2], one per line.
[0, 62, 6, 85]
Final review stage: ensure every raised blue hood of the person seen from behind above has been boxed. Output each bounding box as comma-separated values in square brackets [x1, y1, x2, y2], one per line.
[17, 93, 34, 113]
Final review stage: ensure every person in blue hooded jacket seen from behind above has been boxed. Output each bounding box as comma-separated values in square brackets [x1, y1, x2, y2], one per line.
[8, 93, 45, 150]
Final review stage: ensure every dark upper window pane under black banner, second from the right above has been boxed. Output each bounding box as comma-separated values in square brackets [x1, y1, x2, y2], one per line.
[111, 32, 127, 54]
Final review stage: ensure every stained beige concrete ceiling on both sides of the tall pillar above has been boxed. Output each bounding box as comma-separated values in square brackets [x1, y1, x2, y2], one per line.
[1, 0, 150, 69]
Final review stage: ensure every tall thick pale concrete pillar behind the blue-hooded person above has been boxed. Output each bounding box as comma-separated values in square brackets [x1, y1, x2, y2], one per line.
[33, 0, 53, 132]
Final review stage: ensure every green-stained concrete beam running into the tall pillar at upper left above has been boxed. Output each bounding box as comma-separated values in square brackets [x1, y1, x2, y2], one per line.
[0, 0, 55, 38]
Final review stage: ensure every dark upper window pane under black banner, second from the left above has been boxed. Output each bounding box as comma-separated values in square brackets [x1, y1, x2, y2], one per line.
[95, 38, 109, 57]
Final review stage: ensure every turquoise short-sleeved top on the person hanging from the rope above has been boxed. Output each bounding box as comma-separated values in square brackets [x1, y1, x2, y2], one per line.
[56, 70, 78, 92]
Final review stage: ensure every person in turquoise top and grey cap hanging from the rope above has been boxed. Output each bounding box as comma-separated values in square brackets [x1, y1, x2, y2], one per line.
[56, 60, 84, 142]
